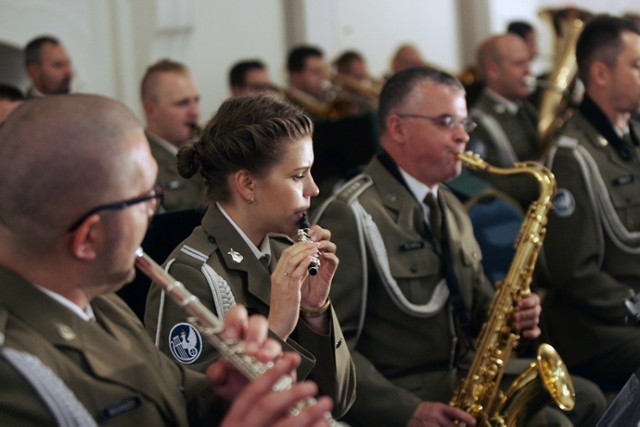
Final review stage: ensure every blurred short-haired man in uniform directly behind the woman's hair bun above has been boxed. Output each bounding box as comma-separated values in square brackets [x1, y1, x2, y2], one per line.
[140, 59, 203, 211]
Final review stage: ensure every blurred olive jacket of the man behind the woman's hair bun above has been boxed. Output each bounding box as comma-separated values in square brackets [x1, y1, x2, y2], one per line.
[146, 131, 204, 211]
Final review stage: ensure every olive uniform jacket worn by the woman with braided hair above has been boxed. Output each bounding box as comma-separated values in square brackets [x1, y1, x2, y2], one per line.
[145, 205, 355, 417]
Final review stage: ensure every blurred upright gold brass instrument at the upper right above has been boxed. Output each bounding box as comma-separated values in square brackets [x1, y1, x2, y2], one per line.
[538, 8, 592, 153]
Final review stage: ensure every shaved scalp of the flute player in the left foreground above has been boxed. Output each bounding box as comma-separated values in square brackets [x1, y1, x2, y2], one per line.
[0, 95, 148, 246]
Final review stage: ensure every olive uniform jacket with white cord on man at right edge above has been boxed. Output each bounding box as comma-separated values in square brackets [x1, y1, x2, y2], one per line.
[543, 102, 640, 375]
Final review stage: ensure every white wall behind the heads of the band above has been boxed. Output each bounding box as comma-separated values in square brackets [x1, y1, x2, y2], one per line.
[0, 0, 640, 121]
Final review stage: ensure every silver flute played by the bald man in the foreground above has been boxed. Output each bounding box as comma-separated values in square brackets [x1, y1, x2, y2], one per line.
[135, 248, 346, 426]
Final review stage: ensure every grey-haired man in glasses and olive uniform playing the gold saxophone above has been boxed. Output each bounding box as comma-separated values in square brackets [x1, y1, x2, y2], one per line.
[314, 68, 604, 426]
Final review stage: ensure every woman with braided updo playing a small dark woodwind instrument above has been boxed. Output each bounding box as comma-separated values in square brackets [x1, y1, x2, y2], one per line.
[145, 95, 355, 417]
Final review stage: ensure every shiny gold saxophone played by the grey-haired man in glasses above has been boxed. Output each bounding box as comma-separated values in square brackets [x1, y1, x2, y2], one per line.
[449, 152, 575, 426]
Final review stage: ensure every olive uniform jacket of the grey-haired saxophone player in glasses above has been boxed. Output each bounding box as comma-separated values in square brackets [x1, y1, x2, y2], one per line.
[314, 157, 493, 426]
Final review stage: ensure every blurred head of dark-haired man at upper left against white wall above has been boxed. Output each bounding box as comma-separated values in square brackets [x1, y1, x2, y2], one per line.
[24, 36, 73, 97]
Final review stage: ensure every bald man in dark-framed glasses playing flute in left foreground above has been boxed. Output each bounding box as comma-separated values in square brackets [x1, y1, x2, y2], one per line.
[0, 95, 331, 427]
